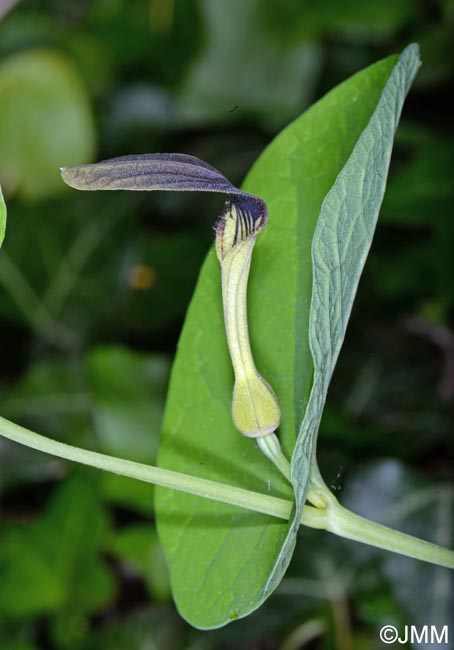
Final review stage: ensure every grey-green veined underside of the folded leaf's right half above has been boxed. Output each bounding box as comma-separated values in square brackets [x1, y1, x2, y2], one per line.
[286, 45, 420, 528]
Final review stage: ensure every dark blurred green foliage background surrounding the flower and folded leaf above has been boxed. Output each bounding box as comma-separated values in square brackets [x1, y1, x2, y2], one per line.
[0, 0, 454, 650]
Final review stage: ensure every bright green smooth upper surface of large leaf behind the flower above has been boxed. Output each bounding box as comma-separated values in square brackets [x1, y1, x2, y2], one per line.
[156, 46, 418, 629]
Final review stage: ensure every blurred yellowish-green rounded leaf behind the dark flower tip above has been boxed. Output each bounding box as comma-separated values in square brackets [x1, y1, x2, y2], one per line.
[0, 50, 95, 197]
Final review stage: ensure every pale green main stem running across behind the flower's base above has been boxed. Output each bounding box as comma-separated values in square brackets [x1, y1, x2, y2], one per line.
[0, 417, 454, 568]
